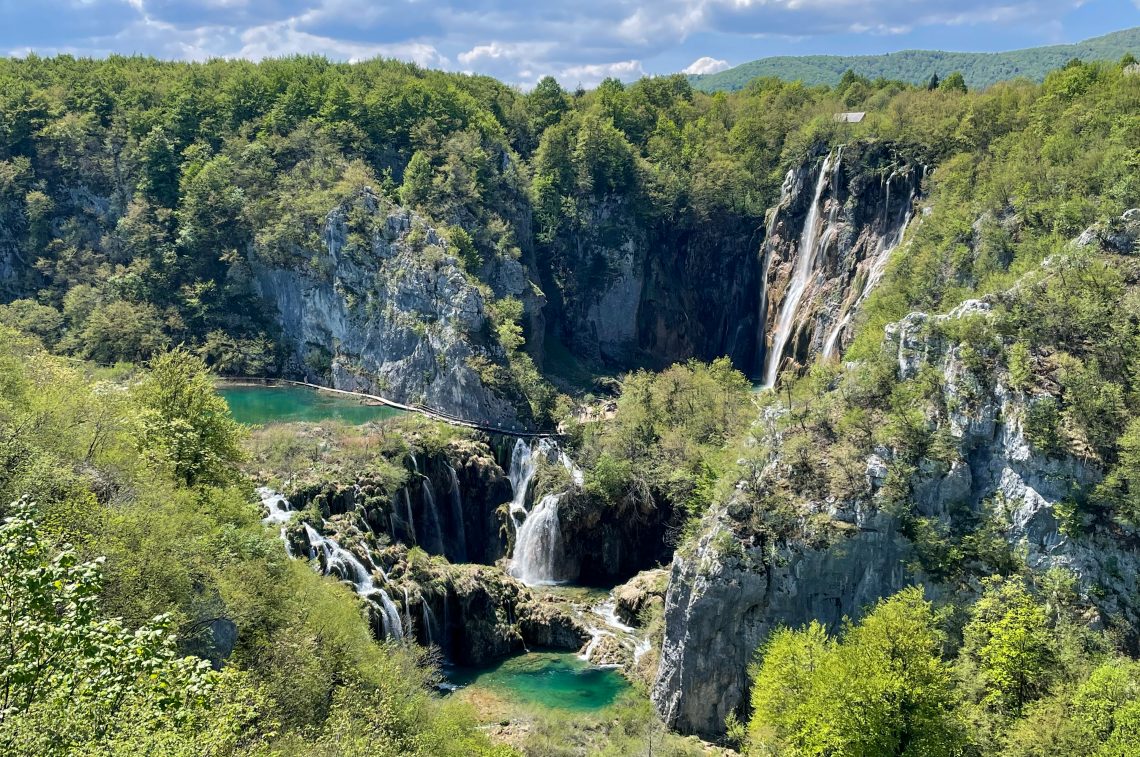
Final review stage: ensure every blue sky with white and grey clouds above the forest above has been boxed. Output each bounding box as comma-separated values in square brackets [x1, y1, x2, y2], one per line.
[0, 0, 1140, 87]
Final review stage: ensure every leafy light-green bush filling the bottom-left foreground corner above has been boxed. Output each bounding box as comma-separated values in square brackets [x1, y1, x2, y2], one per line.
[0, 505, 268, 755]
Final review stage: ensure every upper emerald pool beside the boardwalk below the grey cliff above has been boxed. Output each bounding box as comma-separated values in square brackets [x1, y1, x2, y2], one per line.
[218, 385, 402, 425]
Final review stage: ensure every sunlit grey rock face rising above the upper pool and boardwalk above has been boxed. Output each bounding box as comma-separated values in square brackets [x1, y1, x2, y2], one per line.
[251, 185, 530, 429]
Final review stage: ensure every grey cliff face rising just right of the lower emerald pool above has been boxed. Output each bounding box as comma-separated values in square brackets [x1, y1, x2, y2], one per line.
[652, 513, 911, 738]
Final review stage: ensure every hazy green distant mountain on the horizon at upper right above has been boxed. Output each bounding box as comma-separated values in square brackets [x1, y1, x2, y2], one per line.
[689, 26, 1140, 92]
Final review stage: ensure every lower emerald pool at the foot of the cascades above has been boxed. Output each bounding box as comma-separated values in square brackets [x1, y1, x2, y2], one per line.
[447, 652, 629, 711]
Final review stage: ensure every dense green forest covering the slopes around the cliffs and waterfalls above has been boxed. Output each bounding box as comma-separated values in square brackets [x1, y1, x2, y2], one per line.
[0, 42, 1140, 756]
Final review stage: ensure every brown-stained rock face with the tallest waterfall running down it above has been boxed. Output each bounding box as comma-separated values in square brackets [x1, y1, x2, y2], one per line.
[754, 144, 925, 385]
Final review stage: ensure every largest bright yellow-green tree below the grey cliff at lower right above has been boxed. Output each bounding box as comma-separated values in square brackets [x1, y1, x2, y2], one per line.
[747, 588, 966, 755]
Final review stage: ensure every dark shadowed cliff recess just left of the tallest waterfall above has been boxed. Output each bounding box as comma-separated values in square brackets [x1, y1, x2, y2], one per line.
[540, 198, 762, 366]
